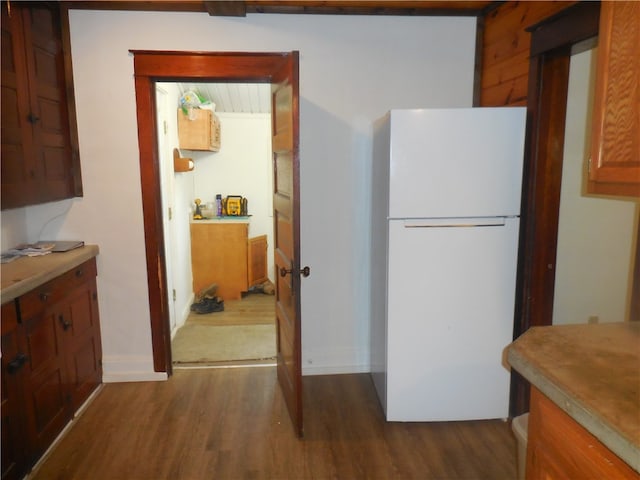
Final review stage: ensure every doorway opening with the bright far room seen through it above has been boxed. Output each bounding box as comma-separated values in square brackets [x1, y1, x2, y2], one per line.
[156, 82, 276, 368]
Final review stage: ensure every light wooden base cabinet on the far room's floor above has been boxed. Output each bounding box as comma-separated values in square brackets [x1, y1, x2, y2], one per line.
[191, 221, 268, 300]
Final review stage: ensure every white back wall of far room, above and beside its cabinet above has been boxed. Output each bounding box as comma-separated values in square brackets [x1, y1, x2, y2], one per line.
[192, 112, 275, 282]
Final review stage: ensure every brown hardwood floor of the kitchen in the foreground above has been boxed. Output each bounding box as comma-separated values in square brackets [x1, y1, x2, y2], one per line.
[30, 367, 516, 480]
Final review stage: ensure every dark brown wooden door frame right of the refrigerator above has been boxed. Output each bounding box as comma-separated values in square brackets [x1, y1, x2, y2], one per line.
[510, 2, 600, 416]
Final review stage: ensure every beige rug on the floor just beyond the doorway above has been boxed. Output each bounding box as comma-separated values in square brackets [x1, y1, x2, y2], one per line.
[172, 324, 276, 364]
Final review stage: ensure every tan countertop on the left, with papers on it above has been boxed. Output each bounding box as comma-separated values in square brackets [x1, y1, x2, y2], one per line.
[0, 245, 99, 303]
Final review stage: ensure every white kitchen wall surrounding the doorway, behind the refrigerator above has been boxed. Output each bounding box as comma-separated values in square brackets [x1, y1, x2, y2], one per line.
[3, 11, 475, 381]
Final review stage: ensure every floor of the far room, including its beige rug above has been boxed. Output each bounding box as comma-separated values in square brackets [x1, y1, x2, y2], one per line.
[171, 294, 276, 366]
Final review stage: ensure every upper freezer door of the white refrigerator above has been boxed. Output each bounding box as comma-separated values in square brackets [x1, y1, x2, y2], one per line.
[388, 107, 526, 218]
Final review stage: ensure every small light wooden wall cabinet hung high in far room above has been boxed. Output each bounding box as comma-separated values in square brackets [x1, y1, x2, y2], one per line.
[178, 108, 220, 152]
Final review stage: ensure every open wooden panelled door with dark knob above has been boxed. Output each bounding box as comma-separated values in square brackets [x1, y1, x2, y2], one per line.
[271, 52, 309, 437]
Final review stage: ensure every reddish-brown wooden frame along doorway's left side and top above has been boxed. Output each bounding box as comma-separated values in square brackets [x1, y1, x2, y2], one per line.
[130, 50, 298, 375]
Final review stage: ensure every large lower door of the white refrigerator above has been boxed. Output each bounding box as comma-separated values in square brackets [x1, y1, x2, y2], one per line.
[387, 218, 519, 421]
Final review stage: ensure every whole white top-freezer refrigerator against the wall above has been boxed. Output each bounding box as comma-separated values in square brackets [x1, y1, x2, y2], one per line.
[371, 107, 526, 421]
